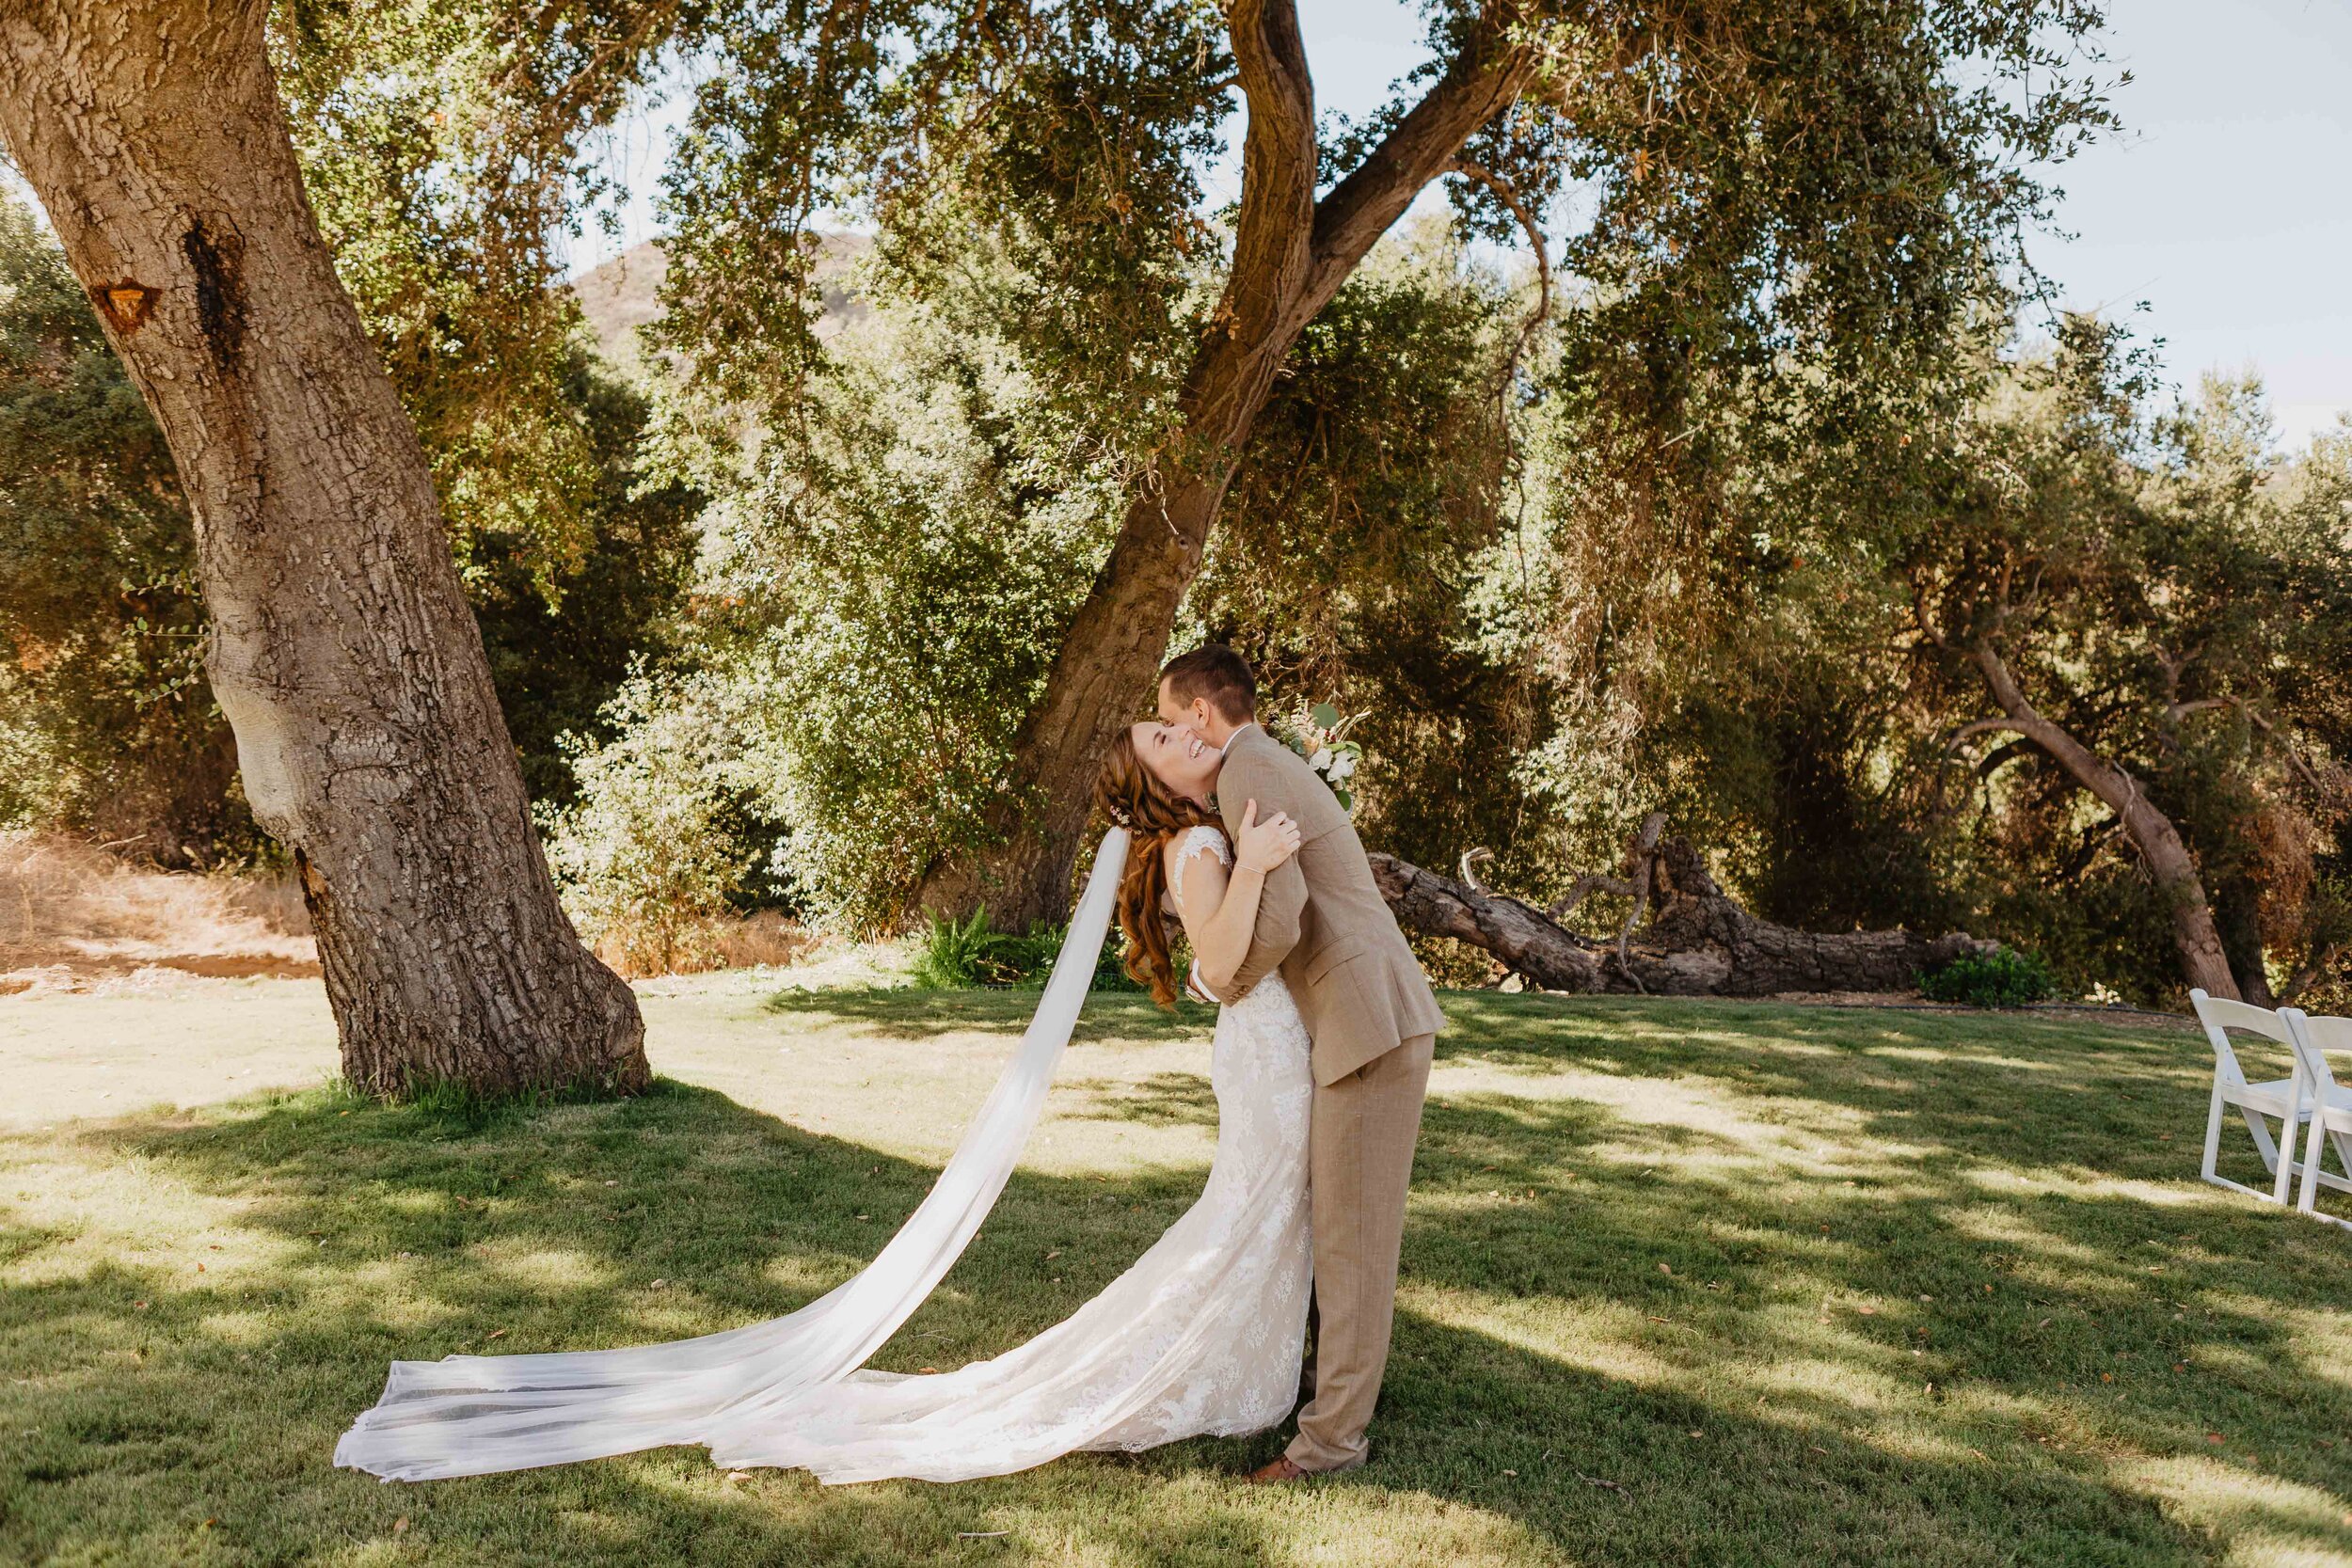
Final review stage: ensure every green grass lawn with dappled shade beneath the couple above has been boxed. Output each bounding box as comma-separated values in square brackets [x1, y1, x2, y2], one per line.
[0, 978, 2352, 1568]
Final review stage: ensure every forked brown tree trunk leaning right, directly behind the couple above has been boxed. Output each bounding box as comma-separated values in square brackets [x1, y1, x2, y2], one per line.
[917, 0, 1536, 928]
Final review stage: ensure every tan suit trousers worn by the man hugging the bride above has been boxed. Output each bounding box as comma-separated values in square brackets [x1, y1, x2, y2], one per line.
[1287, 1035, 1438, 1472]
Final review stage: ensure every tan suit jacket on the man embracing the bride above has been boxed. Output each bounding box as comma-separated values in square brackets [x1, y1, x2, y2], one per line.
[1216, 724, 1444, 1084]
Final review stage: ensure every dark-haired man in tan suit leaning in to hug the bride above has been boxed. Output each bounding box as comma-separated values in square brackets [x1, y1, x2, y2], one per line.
[1160, 644, 1444, 1481]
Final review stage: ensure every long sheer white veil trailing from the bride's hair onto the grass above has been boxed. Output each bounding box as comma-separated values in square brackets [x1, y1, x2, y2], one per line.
[334, 828, 1129, 1481]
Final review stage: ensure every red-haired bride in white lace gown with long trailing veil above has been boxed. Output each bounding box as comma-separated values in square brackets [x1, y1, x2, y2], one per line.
[334, 724, 1315, 1483]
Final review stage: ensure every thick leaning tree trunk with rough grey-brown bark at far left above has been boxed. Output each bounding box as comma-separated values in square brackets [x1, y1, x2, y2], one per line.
[0, 0, 649, 1093]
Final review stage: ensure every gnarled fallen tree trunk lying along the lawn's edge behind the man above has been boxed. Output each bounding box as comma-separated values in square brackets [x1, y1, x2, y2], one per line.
[1372, 818, 1997, 997]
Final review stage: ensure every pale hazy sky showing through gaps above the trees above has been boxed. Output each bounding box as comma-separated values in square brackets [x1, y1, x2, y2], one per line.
[546, 0, 2352, 444]
